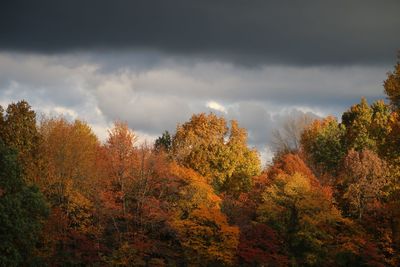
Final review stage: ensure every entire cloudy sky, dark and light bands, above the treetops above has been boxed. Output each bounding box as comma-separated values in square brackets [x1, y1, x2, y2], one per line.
[0, 0, 400, 163]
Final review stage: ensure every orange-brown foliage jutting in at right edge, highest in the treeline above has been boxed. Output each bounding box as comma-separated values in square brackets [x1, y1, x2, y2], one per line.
[383, 53, 400, 110]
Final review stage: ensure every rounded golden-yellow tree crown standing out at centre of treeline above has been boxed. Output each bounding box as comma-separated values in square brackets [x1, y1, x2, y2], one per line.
[173, 113, 260, 193]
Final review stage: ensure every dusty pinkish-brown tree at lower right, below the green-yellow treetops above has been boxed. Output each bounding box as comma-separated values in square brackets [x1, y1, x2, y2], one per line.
[336, 150, 396, 266]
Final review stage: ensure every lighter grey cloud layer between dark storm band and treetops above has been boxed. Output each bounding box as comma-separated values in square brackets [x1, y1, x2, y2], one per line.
[0, 53, 389, 158]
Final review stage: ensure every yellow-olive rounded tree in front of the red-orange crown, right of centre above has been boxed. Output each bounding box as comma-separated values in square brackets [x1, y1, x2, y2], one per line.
[258, 172, 343, 265]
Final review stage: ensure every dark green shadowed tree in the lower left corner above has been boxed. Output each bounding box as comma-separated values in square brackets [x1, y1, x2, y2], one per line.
[0, 140, 48, 266]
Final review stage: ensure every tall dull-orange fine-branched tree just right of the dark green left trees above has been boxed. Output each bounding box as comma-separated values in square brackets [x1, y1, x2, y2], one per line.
[38, 118, 100, 264]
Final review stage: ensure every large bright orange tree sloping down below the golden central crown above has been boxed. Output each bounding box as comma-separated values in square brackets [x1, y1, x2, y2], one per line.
[103, 148, 239, 266]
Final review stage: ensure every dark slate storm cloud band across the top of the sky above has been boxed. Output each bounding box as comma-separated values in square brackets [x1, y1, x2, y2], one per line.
[0, 0, 400, 65]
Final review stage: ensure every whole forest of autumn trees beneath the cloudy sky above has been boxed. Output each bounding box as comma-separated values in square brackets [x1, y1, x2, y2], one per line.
[0, 58, 400, 266]
